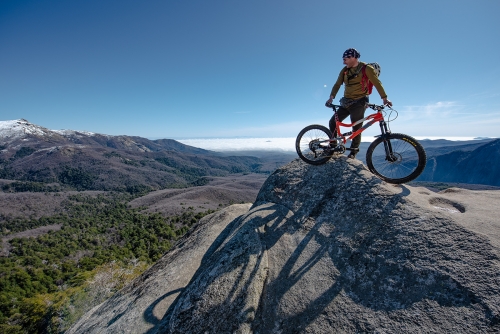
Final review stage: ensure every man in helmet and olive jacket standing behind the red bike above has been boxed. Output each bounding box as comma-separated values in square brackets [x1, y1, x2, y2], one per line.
[327, 48, 392, 159]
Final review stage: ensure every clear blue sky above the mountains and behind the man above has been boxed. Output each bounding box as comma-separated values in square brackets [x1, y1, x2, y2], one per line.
[0, 0, 500, 138]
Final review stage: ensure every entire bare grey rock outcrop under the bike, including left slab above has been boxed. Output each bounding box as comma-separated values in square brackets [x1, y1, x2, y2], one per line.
[69, 157, 500, 333]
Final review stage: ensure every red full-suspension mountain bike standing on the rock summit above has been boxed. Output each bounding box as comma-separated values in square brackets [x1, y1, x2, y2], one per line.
[295, 103, 427, 184]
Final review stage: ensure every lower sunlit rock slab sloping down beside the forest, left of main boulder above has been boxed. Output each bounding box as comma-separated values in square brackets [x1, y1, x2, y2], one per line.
[66, 204, 251, 334]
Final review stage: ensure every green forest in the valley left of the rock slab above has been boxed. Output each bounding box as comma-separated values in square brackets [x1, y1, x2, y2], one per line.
[0, 193, 214, 333]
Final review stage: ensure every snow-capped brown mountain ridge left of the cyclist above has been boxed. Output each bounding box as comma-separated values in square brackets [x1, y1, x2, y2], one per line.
[0, 119, 262, 192]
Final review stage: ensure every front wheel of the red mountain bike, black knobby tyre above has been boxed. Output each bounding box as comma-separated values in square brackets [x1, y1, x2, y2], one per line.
[366, 133, 427, 184]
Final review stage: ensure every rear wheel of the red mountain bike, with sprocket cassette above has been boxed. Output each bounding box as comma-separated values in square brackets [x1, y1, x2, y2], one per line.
[295, 125, 333, 165]
